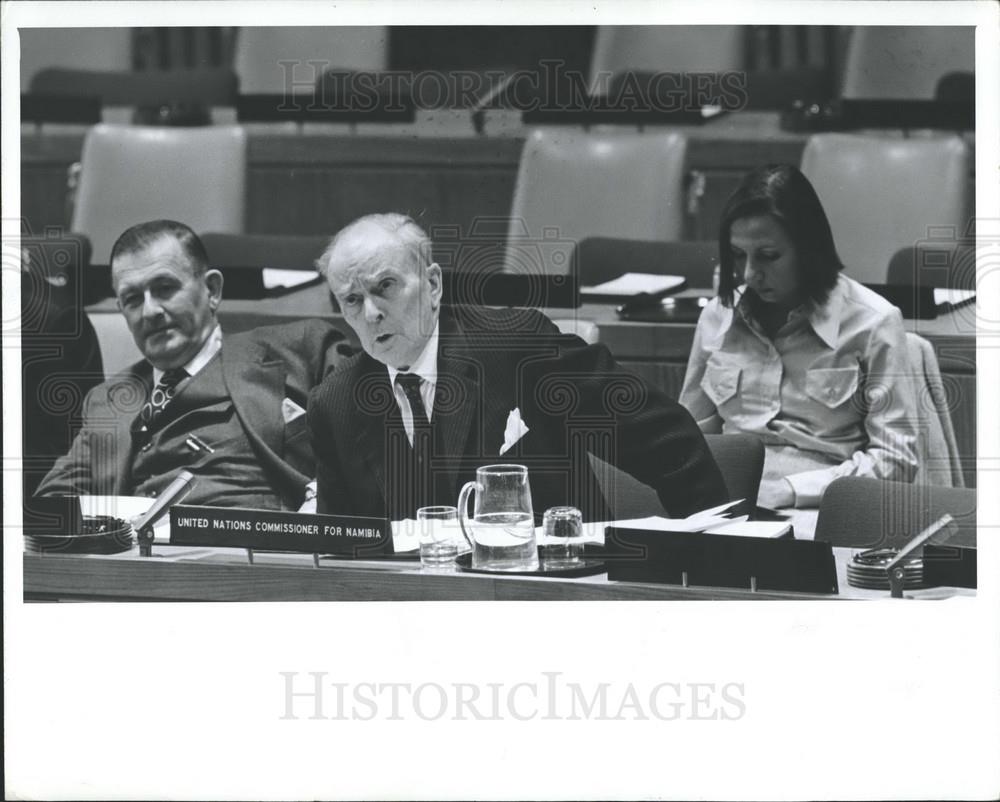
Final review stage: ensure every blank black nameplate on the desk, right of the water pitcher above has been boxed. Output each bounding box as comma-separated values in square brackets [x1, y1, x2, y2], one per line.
[604, 526, 838, 594]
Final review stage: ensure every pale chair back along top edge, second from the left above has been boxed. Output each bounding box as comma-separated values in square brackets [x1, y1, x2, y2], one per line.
[234, 25, 389, 95]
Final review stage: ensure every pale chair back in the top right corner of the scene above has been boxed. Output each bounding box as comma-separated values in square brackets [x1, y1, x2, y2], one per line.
[840, 25, 976, 100]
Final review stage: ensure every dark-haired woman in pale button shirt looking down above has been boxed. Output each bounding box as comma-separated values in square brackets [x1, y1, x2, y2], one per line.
[680, 164, 917, 507]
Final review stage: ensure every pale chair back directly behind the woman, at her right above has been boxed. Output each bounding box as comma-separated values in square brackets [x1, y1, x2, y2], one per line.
[802, 134, 971, 284]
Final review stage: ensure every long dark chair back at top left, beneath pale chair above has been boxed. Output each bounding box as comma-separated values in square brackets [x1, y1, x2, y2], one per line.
[30, 67, 238, 109]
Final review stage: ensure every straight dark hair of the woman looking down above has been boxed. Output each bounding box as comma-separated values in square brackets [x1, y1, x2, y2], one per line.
[719, 164, 844, 312]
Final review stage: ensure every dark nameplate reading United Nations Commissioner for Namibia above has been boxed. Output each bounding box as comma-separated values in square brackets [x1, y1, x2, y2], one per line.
[170, 504, 392, 557]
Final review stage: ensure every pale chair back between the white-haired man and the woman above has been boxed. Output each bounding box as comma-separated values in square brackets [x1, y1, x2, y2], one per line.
[504, 127, 687, 274]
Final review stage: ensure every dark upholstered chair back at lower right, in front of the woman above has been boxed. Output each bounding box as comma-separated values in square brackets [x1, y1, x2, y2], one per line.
[816, 476, 976, 549]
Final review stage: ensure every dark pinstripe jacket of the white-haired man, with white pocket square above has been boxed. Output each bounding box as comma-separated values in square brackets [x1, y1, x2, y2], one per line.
[308, 308, 727, 520]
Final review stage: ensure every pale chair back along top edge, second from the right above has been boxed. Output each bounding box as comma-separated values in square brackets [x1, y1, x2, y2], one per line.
[590, 25, 746, 92]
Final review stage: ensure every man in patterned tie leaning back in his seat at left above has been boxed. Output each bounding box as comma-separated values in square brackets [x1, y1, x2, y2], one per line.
[37, 220, 344, 509]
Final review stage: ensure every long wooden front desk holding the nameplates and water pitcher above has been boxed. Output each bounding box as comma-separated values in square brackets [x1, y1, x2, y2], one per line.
[24, 546, 975, 602]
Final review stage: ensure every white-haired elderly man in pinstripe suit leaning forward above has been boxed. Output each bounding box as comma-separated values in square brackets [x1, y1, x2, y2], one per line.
[308, 214, 726, 520]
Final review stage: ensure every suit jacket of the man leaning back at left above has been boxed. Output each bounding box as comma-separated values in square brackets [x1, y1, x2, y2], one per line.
[38, 320, 349, 509]
